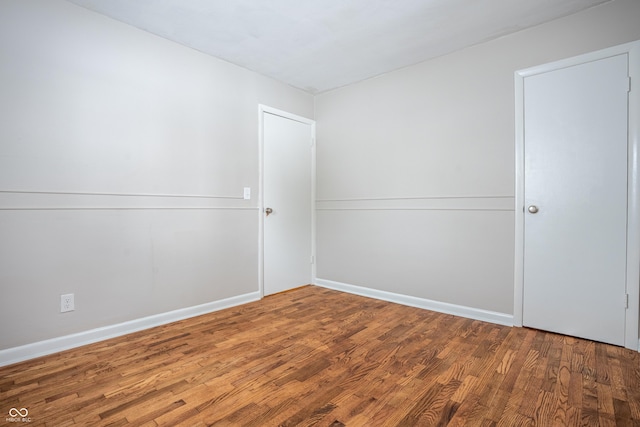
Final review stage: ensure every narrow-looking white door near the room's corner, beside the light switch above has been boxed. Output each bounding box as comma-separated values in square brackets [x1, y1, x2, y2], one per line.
[262, 112, 314, 295]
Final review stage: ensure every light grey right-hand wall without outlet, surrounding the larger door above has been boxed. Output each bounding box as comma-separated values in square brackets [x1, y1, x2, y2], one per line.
[316, 0, 640, 315]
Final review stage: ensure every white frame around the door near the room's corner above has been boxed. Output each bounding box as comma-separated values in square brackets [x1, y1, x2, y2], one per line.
[258, 104, 316, 298]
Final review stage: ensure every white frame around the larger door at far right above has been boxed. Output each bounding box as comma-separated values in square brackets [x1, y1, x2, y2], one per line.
[513, 41, 640, 351]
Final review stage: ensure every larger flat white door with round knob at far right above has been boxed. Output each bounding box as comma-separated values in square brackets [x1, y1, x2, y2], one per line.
[522, 54, 629, 345]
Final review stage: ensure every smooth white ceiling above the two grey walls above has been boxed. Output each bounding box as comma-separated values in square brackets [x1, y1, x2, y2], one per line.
[69, 0, 611, 93]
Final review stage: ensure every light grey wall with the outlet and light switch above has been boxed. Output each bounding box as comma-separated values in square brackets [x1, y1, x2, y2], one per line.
[0, 0, 313, 350]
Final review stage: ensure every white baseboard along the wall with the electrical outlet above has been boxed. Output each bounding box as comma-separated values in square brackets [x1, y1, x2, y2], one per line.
[0, 292, 261, 366]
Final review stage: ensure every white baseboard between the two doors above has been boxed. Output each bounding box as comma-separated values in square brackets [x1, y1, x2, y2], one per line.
[315, 279, 513, 326]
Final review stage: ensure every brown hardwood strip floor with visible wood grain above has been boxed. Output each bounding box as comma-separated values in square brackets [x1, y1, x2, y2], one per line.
[0, 286, 640, 427]
